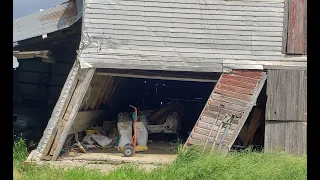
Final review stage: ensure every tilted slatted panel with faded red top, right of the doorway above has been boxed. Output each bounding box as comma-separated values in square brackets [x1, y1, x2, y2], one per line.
[185, 70, 266, 151]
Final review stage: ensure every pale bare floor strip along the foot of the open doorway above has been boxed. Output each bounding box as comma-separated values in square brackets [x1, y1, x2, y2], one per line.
[36, 142, 177, 172]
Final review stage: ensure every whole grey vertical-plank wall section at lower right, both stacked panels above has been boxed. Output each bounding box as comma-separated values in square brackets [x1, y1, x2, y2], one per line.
[265, 70, 307, 154]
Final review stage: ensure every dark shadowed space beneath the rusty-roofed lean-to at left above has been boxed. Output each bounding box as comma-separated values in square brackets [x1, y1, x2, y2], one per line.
[13, 21, 81, 148]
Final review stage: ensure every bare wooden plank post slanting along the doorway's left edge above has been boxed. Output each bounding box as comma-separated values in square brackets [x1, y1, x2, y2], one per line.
[51, 68, 96, 160]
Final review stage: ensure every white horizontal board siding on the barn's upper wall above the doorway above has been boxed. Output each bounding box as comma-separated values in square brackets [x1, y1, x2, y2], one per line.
[79, 0, 306, 72]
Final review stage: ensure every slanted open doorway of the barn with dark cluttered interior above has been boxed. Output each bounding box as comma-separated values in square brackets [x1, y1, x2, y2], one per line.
[60, 73, 220, 163]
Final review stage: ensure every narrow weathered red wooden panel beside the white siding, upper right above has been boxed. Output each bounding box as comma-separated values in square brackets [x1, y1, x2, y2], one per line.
[287, 0, 307, 54]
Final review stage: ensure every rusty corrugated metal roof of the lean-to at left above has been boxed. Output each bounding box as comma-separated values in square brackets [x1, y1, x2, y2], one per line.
[13, 0, 83, 43]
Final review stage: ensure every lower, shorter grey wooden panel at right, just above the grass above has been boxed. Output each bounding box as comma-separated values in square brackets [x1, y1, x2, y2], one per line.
[264, 121, 307, 155]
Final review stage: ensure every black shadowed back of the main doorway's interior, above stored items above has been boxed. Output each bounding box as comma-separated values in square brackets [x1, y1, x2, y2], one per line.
[99, 78, 215, 140]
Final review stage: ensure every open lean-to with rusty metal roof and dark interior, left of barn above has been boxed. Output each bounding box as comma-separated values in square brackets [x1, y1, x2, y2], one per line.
[13, 1, 82, 148]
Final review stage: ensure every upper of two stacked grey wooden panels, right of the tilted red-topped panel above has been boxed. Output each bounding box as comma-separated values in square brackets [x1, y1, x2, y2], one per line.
[266, 70, 307, 121]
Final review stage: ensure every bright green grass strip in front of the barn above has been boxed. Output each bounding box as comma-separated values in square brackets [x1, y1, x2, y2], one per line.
[13, 141, 307, 180]
